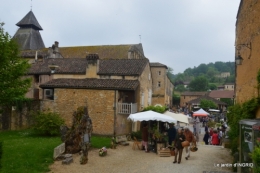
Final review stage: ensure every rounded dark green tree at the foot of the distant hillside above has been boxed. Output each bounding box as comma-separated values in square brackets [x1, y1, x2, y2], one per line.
[189, 76, 209, 91]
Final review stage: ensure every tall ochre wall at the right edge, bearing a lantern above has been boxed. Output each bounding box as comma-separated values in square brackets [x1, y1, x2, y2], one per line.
[235, 0, 260, 109]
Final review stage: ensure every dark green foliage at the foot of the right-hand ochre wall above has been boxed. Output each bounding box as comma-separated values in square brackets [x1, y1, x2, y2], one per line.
[227, 98, 260, 154]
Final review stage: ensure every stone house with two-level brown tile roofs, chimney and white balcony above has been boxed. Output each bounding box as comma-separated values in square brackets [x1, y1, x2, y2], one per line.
[28, 54, 152, 135]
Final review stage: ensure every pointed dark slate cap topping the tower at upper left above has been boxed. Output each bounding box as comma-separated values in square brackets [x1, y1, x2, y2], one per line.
[16, 11, 43, 30]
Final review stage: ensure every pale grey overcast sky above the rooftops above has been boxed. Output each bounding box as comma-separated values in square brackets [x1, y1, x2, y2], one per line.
[0, 0, 240, 74]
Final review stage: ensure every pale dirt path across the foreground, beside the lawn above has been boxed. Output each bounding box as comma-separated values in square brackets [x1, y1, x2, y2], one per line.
[50, 142, 232, 173]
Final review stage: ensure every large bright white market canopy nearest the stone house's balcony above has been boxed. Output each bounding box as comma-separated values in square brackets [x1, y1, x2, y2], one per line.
[127, 111, 177, 123]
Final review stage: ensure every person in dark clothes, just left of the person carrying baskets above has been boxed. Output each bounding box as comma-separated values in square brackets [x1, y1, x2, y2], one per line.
[173, 128, 185, 164]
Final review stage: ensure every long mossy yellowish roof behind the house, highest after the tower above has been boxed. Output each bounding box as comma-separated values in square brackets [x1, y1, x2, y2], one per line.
[21, 44, 145, 59]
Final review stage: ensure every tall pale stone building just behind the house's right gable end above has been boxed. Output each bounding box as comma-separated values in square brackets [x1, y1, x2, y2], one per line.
[150, 62, 173, 107]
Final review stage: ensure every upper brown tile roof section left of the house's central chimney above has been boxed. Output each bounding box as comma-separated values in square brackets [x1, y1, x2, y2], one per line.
[28, 58, 87, 75]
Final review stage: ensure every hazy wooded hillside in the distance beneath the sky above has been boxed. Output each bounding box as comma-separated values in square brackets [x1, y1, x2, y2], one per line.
[168, 61, 235, 91]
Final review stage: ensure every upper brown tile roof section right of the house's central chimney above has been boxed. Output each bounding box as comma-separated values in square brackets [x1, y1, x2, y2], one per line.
[98, 58, 149, 76]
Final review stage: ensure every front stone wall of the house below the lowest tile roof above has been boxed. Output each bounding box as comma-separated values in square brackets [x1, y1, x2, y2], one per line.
[41, 88, 115, 135]
